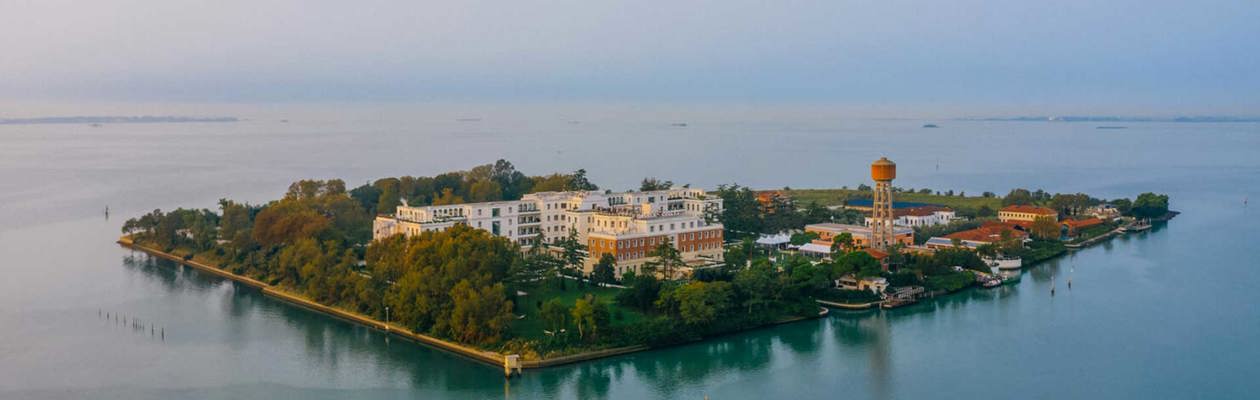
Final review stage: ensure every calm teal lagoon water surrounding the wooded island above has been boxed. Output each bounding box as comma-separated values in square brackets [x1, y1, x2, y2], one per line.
[0, 107, 1260, 399]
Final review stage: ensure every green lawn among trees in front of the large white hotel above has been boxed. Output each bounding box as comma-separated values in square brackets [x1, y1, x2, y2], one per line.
[512, 280, 644, 339]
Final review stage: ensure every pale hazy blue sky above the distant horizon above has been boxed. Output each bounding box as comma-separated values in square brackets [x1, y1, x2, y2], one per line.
[0, 0, 1260, 115]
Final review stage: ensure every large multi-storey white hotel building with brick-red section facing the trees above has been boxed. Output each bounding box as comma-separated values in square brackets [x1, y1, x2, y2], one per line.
[373, 188, 722, 276]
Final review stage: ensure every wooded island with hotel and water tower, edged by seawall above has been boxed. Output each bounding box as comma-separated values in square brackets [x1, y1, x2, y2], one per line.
[118, 159, 1174, 375]
